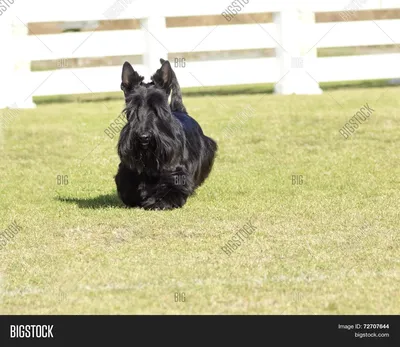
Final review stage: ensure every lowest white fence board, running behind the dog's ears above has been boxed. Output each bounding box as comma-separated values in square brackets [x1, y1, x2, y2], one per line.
[25, 58, 278, 96]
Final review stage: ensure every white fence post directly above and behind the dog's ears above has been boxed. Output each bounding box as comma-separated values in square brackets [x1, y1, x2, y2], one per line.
[140, 13, 168, 75]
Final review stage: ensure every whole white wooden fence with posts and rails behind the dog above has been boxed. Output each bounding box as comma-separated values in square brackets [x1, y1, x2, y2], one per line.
[0, 0, 400, 108]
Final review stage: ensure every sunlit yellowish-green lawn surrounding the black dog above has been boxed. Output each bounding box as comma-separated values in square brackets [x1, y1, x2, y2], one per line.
[0, 87, 400, 314]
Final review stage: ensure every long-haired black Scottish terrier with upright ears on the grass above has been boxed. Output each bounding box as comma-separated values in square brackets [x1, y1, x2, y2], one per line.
[115, 59, 217, 210]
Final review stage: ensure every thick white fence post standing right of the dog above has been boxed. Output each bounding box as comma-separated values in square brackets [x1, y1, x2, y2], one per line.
[274, 8, 322, 94]
